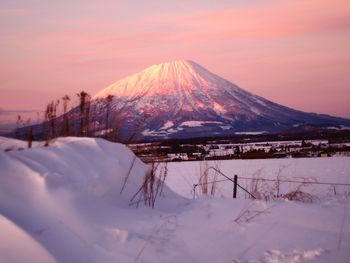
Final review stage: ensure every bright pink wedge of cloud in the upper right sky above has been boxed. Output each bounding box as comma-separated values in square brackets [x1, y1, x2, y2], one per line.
[137, 0, 350, 41]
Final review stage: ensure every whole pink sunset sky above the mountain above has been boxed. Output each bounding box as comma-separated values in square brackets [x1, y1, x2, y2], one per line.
[0, 0, 350, 118]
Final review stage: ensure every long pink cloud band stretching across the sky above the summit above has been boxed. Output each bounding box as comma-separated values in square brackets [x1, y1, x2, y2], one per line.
[4, 1, 350, 60]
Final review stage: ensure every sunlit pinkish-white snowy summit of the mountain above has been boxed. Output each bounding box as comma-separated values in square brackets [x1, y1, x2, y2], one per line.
[94, 59, 227, 99]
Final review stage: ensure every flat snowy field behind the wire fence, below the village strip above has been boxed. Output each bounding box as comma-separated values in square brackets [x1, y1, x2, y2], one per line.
[166, 157, 350, 198]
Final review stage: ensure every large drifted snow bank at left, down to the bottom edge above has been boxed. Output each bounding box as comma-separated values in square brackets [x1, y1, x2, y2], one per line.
[0, 138, 178, 262]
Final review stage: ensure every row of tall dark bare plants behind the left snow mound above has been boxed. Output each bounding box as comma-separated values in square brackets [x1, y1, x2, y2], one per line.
[15, 90, 143, 147]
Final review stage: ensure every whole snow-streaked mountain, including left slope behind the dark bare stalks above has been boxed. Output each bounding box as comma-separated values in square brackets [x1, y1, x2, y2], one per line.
[9, 60, 350, 142]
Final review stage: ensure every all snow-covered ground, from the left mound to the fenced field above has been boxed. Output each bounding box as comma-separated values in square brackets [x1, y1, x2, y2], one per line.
[0, 138, 350, 262]
